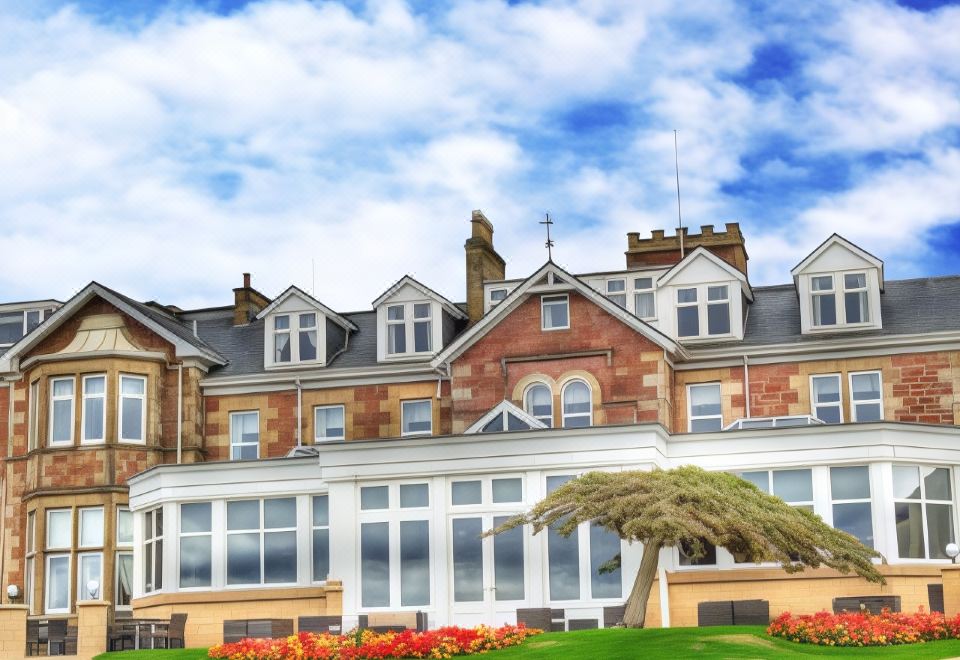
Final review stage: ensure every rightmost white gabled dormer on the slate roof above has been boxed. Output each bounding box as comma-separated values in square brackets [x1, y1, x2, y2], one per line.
[790, 234, 883, 335]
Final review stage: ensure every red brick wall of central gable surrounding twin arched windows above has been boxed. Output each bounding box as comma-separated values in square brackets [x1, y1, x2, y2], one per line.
[452, 293, 669, 433]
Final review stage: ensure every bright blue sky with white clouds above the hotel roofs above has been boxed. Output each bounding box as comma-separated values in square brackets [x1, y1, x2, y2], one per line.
[0, 0, 960, 311]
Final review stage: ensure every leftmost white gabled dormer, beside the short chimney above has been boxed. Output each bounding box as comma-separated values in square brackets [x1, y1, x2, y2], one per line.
[257, 286, 357, 369]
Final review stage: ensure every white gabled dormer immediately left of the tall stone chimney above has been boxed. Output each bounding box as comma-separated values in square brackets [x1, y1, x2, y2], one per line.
[373, 275, 467, 362]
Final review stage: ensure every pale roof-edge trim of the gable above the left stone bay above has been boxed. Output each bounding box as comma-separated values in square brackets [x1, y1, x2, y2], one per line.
[0, 282, 226, 372]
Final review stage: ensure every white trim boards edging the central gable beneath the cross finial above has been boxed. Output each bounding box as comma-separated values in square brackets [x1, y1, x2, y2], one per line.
[431, 261, 686, 367]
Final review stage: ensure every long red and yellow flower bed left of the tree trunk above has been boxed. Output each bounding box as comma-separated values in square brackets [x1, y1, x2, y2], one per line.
[209, 625, 543, 660]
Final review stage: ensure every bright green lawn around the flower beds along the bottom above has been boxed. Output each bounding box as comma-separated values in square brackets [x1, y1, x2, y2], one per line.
[88, 626, 960, 660]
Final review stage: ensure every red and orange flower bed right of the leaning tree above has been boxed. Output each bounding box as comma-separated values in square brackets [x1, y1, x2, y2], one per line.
[767, 607, 960, 646]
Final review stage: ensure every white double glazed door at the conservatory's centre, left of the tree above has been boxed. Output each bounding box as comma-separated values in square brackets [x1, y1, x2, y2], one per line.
[449, 514, 529, 626]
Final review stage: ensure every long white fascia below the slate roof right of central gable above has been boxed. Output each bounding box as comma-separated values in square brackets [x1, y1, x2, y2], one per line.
[675, 330, 960, 371]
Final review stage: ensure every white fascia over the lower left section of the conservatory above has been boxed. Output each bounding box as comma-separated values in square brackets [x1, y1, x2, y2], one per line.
[128, 456, 318, 510]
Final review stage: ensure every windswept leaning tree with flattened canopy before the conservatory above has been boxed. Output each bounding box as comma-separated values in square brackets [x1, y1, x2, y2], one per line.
[486, 466, 884, 628]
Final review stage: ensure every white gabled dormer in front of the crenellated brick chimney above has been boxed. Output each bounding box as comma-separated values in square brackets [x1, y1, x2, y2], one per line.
[657, 247, 753, 343]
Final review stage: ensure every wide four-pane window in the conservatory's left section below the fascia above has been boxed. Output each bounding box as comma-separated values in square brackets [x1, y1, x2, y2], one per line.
[227, 497, 297, 585]
